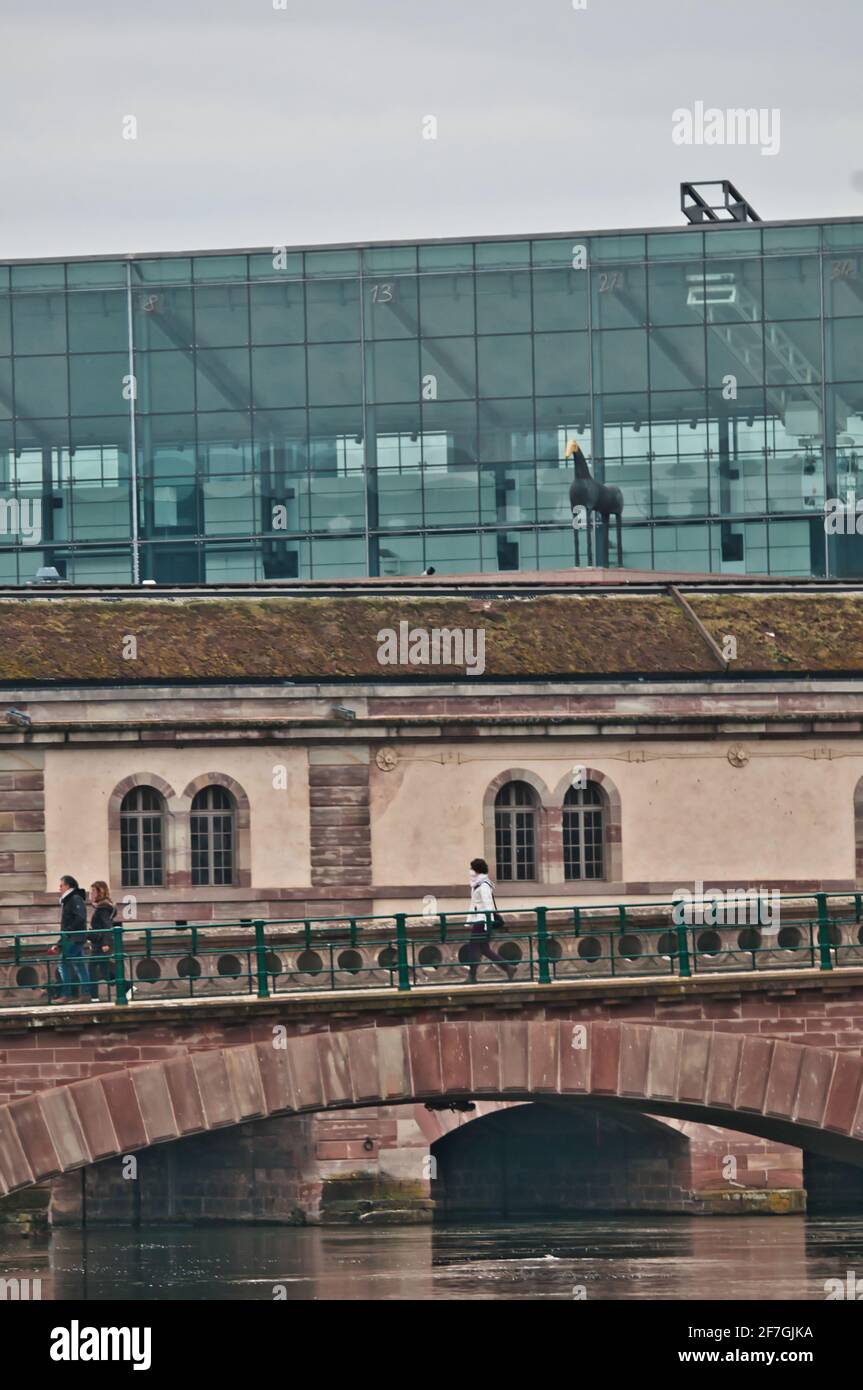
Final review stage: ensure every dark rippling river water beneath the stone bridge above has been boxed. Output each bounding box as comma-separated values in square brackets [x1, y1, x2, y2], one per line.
[0, 1216, 863, 1301]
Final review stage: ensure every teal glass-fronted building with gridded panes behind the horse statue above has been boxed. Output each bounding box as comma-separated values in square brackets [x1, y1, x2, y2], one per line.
[0, 220, 863, 584]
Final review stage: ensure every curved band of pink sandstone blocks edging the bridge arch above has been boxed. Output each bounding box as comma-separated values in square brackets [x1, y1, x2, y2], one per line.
[0, 1019, 863, 1195]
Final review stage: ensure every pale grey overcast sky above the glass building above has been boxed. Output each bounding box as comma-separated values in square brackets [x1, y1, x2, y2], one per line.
[0, 0, 863, 257]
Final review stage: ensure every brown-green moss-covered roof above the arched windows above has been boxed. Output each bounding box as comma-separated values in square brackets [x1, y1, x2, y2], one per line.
[0, 585, 863, 684]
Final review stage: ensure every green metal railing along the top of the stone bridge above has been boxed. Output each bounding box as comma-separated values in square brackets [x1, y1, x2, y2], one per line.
[0, 892, 863, 1008]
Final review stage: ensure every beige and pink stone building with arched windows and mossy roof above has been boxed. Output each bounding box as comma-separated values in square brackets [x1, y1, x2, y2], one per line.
[0, 571, 863, 1219]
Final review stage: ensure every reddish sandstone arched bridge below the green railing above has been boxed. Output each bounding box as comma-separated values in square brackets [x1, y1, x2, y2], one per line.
[0, 967, 863, 1194]
